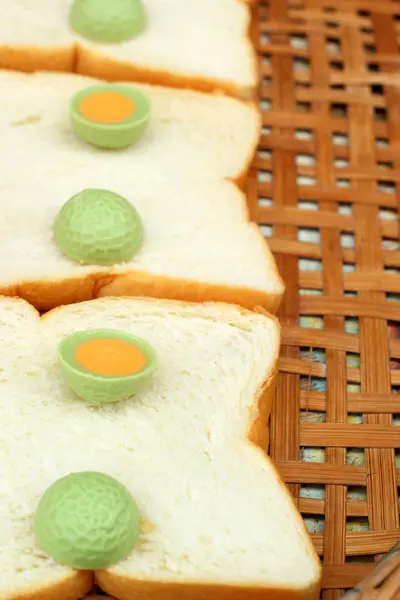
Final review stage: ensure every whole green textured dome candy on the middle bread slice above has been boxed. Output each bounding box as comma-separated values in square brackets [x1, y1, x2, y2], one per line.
[54, 189, 143, 265]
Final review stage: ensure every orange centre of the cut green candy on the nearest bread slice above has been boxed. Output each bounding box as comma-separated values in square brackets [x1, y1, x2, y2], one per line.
[75, 338, 147, 377]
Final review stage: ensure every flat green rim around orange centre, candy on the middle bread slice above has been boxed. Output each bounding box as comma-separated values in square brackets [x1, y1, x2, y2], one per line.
[70, 83, 151, 132]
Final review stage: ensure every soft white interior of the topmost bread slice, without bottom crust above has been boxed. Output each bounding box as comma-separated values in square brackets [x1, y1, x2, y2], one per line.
[0, 0, 256, 88]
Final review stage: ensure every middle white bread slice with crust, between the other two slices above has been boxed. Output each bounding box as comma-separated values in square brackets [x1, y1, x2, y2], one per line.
[0, 71, 284, 312]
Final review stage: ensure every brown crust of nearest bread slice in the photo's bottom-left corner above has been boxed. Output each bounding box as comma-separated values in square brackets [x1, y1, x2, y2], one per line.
[0, 571, 93, 600]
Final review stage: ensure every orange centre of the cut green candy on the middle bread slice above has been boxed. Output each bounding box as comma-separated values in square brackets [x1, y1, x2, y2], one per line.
[79, 91, 135, 125]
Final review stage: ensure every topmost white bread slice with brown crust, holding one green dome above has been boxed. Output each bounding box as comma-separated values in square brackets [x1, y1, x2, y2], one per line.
[0, 0, 257, 97]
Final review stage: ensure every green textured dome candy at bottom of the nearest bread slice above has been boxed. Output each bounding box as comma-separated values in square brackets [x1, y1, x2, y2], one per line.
[34, 471, 140, 570]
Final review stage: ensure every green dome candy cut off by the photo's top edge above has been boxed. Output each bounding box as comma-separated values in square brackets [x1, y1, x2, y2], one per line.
[70, 0, 146, 43]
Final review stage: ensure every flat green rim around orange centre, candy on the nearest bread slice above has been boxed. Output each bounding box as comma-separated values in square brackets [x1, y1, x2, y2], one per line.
[57, 329, 157, 384]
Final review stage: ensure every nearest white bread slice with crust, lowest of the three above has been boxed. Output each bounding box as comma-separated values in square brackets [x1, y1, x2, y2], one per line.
[0, 298, 320, 600]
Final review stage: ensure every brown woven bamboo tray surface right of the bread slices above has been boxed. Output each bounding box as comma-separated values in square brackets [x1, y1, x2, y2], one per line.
[248, 0, 400, 600]
